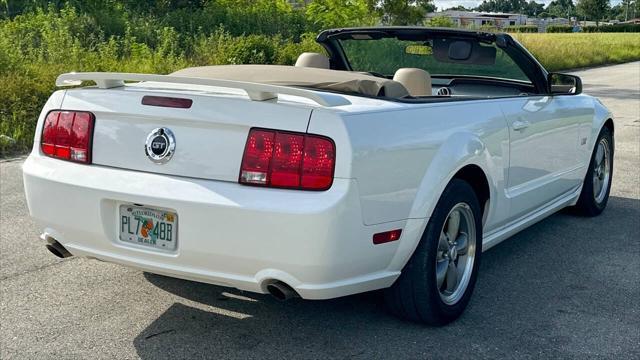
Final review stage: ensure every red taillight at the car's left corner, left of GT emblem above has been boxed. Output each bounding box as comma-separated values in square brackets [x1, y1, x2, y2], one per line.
[40, 110, 94, 164]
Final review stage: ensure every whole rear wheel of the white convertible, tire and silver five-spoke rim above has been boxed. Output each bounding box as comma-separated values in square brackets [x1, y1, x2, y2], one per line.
[385, 179, 482, 325]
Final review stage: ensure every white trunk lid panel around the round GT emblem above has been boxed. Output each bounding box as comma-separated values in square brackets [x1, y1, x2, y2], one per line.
[62, 86, 312, 182]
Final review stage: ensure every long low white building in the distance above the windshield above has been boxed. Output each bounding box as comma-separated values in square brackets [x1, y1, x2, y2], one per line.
[427, 10, 527, 29]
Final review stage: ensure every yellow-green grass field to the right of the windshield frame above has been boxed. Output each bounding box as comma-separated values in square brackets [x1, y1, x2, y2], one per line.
[512, 33, 640, 71]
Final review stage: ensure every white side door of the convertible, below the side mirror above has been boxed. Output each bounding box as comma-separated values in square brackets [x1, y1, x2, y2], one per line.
[501, 95, 593, 219]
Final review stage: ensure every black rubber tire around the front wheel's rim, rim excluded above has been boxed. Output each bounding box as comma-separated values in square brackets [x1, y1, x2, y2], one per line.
[574, 127, 615, 216]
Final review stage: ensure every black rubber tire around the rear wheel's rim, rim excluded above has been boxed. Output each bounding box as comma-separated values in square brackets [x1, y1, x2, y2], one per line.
[385, 179, 482, 326]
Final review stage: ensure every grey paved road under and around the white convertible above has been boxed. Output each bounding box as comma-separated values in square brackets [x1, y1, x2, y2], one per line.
[0, 62, 640, 359]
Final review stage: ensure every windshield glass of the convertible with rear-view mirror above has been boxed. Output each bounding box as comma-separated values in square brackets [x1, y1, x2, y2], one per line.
[338, 37, 531, 83]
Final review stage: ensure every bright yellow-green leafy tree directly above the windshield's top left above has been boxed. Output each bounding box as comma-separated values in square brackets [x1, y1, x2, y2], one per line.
[306, 0, 376, 29]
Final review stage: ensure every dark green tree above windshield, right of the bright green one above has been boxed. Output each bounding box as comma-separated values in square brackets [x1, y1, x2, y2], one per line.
[368, 0, 436, 25]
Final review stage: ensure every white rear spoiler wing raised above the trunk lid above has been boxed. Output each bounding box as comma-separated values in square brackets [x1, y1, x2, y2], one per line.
[56, 72, 351, 107]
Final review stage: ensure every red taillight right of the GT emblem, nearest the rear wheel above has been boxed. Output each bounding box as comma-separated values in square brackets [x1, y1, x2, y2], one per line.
[239, 129, 336, 190]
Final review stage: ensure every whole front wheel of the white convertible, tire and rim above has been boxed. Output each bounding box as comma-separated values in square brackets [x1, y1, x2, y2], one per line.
[575, 127, 613, 216]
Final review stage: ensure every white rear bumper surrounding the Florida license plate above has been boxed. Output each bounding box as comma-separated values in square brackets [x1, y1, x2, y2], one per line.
[23, 154, 407, 299]
